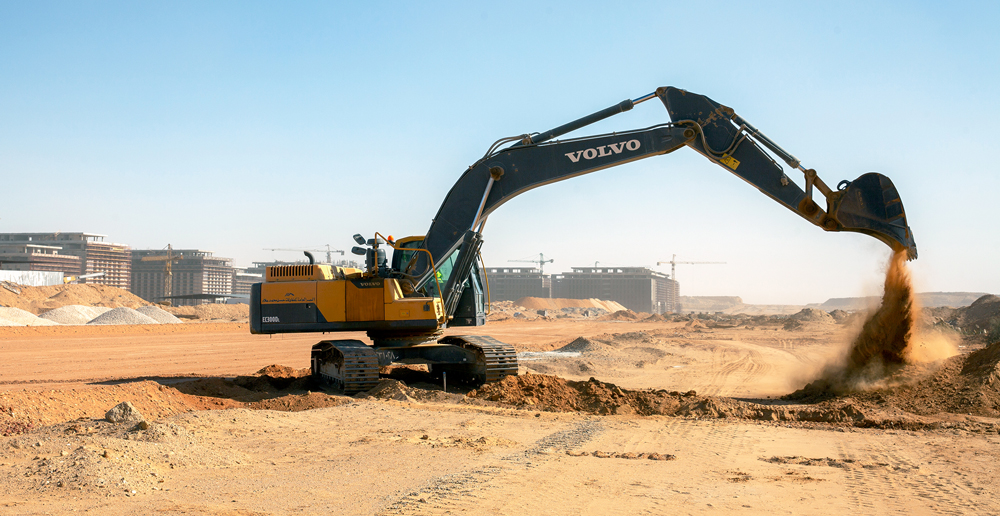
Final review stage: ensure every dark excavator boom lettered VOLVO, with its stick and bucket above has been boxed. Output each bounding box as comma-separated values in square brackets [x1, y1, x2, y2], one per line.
[405, 87, 917, 315]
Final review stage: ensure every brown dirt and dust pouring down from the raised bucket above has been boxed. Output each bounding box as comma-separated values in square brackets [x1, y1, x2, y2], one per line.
[786, 251, 958, 399]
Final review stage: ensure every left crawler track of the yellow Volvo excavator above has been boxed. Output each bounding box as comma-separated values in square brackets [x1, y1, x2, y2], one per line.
[312, 340, 379, 394]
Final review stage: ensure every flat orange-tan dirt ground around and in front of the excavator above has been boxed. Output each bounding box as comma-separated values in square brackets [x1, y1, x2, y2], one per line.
[0, 317, 1000, 515]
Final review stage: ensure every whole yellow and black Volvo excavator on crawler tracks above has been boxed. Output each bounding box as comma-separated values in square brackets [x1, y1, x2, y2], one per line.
[250, 87, 917, 394]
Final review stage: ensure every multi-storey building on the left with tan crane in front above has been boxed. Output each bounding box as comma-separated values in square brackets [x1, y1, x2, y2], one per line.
[132, 249, 233, 306]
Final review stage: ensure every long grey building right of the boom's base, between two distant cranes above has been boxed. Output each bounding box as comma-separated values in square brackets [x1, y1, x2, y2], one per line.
[552, 267, 679, 314]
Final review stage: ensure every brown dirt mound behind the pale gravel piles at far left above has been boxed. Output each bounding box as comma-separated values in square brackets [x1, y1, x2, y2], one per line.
[0, 284, 149, 314]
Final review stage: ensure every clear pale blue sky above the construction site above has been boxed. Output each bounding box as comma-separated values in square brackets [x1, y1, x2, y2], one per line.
[0, 0, 1000, 303]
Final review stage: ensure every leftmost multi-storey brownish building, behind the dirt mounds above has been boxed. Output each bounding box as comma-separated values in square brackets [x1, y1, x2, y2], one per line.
[0, 233, 132, 290]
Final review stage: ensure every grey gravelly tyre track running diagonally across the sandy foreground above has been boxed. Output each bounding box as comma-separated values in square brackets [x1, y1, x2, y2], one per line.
[379, 420, 604, 516]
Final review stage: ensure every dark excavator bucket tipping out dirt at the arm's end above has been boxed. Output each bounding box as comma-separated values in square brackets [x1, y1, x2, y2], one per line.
[829, 172, 917, 260]
